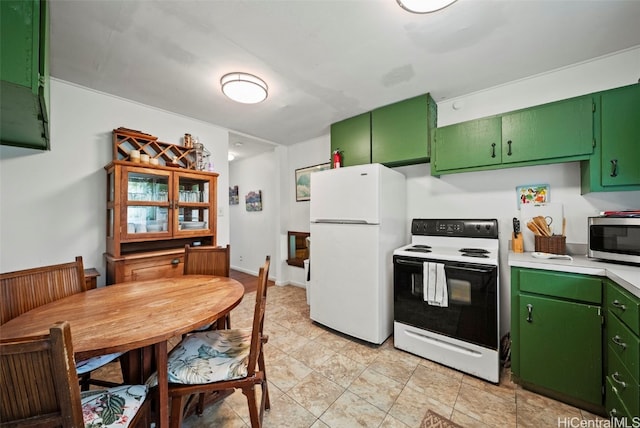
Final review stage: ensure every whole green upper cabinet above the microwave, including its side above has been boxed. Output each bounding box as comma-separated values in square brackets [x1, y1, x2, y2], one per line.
[581, 84, 640, 193]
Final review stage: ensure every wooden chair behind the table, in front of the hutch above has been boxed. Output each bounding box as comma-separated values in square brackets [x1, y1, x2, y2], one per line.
[183, 244, 231, 330]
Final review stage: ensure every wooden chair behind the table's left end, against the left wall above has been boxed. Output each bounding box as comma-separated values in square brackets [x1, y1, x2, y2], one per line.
[0, 256, 121, 390]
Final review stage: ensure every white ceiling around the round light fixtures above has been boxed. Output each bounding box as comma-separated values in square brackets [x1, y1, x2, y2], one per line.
[50, 0, 640, 160]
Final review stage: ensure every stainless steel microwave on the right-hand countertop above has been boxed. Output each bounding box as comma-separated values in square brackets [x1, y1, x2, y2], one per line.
[587, 217, 640, 265]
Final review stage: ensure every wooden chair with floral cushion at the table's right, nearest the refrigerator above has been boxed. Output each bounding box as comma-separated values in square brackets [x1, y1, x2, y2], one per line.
[162, 256, 271, 428]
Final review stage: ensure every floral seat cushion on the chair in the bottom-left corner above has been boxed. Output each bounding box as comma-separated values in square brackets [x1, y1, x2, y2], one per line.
[80, 385, 147, 428]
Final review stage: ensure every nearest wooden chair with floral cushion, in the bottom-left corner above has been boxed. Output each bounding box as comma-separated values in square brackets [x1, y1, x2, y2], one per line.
[0, 321, 150, 428]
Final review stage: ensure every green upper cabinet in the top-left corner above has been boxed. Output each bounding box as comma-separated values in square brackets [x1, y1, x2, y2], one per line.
[0, 0, 50, 150]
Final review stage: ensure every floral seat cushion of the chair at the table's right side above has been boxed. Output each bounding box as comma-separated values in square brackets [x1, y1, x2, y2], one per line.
[147, 329, 251, 387]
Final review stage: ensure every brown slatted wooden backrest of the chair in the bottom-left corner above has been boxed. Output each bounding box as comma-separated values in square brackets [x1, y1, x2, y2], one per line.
[0, 321, 84, 428]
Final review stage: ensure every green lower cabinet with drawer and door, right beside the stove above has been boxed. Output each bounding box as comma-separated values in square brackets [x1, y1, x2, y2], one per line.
[511, 267, 604, 414]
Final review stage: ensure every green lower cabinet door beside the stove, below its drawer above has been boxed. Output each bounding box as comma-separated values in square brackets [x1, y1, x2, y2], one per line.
[512, 294, 603, 406]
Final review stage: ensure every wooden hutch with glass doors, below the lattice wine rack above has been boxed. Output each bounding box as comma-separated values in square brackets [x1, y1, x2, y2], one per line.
[105, 130, 218, 284]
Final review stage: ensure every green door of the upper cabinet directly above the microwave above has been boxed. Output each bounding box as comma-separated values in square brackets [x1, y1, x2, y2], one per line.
[600, 84, 640, 190]
